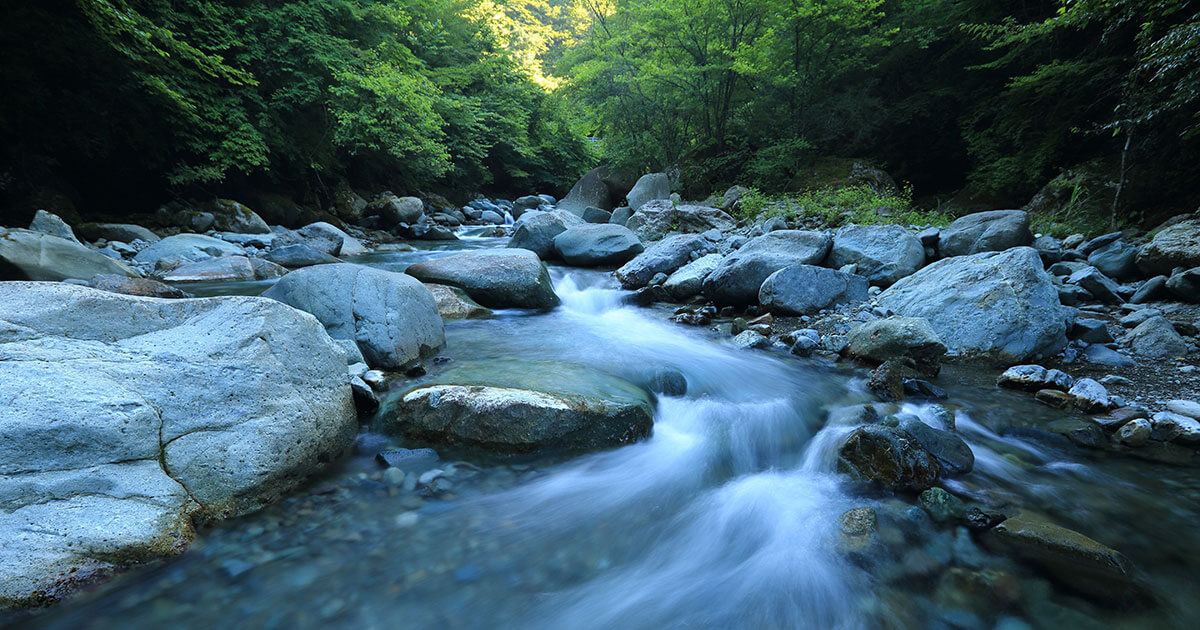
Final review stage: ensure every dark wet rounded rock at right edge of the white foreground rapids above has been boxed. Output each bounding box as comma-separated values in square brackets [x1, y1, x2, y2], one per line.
[838, 425, 941, 492]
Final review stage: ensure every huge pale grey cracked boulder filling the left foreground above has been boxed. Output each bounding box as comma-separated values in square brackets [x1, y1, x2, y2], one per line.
[0, 282, 358, 607]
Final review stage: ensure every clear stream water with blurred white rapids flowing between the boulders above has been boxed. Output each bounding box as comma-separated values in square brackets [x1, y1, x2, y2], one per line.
[12, 233, 1200, 630]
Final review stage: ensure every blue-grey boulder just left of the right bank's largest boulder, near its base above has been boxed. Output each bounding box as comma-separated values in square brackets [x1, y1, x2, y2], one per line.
[758, 265, 868, 316]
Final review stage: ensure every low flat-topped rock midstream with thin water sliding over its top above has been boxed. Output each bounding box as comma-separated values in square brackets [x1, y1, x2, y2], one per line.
[384, 361, 654, 452]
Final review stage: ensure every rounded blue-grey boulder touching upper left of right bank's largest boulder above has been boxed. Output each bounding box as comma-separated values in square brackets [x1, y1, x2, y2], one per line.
[826, 226, 925, 287]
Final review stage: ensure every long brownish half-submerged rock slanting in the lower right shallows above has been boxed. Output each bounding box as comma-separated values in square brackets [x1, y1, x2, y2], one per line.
[984, 515, 1134, 601]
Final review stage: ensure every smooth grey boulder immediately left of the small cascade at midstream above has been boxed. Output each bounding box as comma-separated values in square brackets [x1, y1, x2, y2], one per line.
[404, 248, 559, 308]
